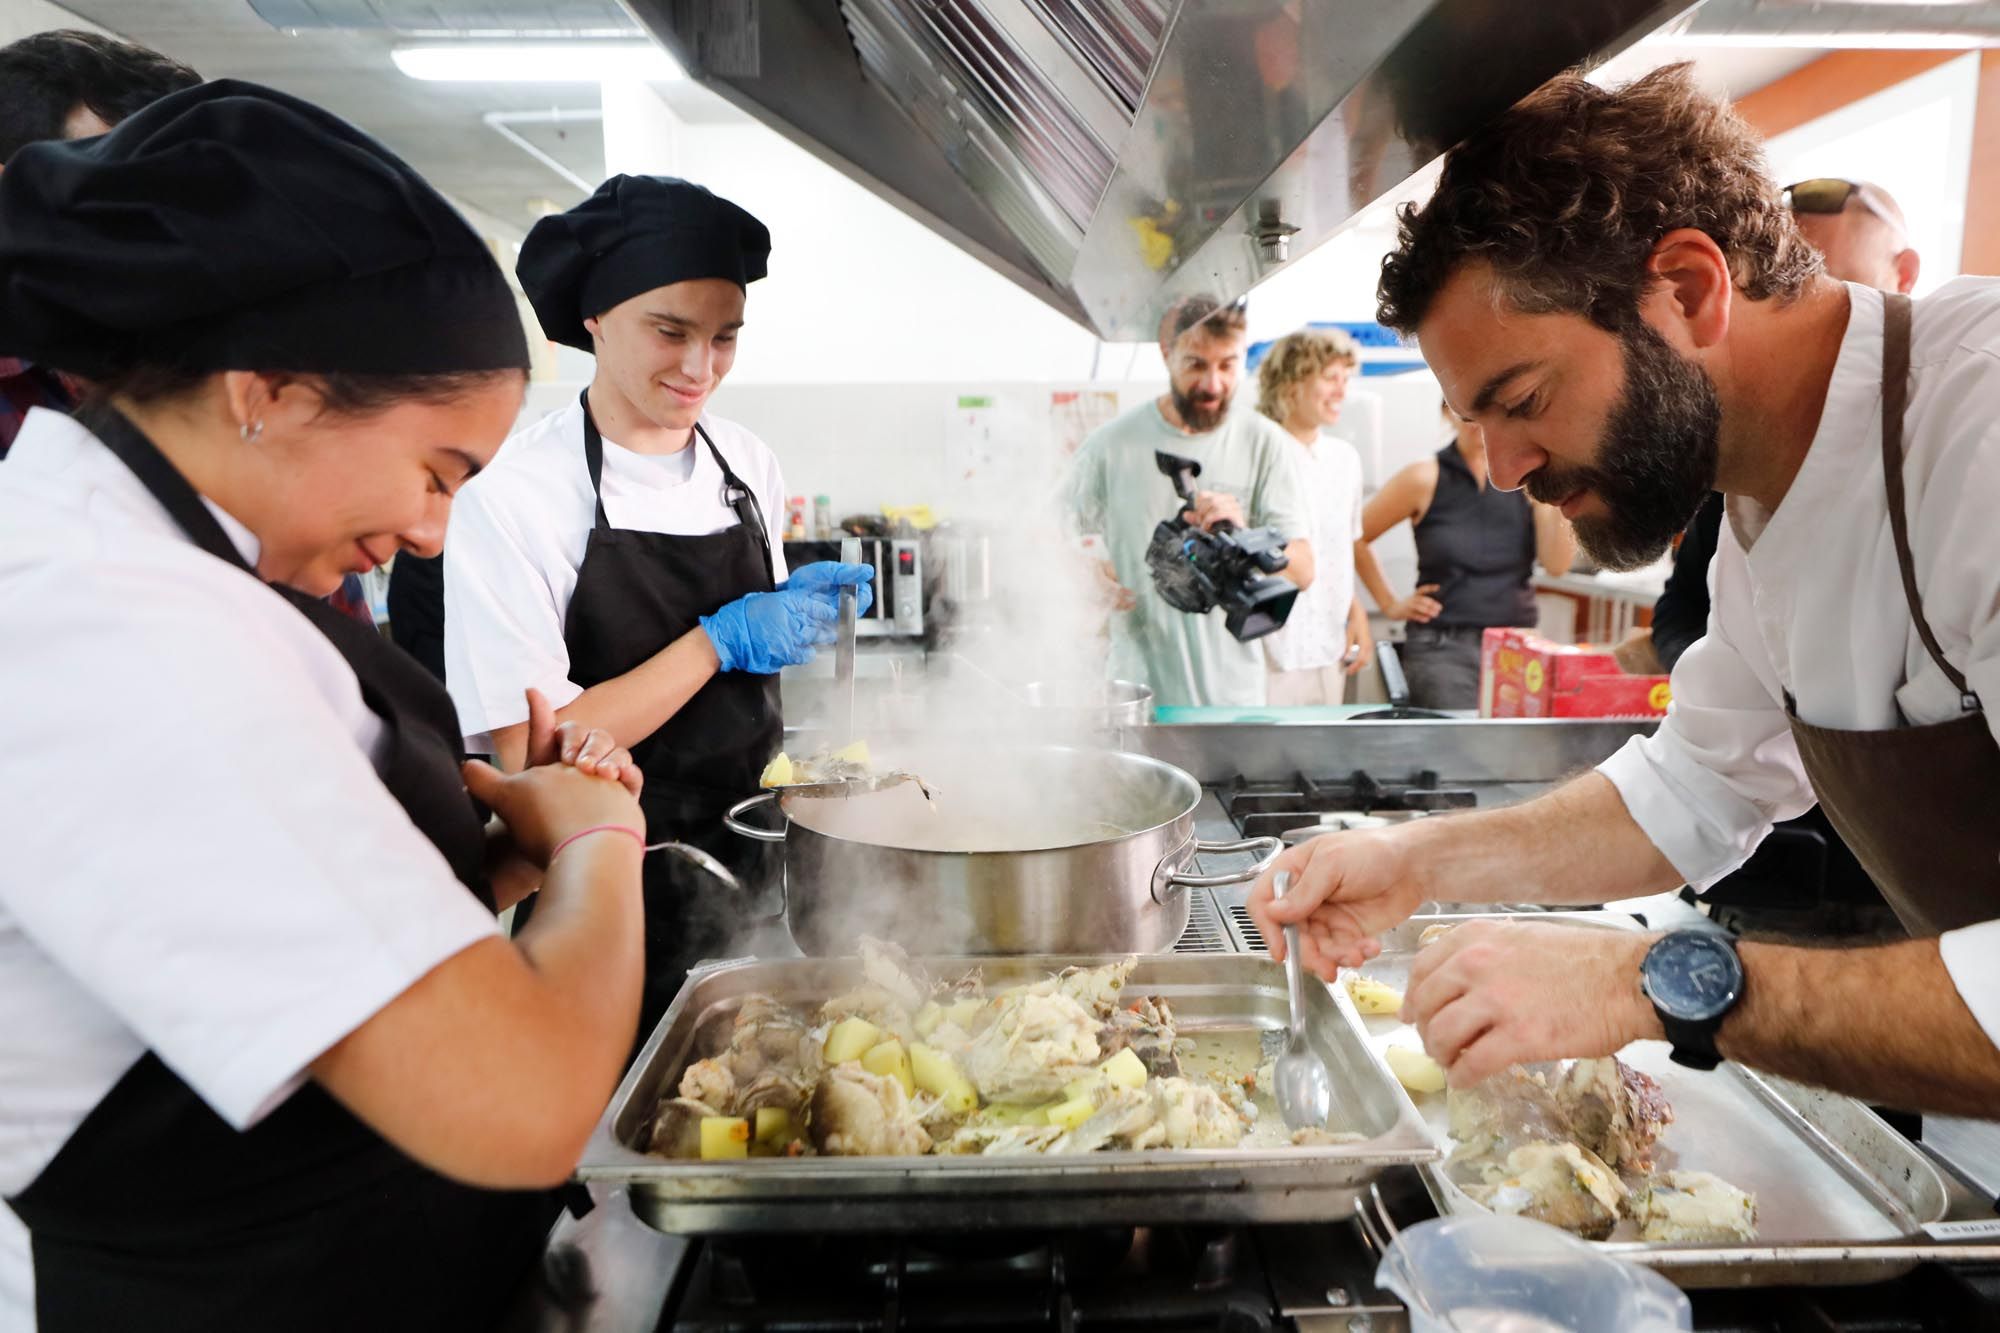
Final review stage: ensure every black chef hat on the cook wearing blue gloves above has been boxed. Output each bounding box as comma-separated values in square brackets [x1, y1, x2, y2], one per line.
[514, 176, 770, 352]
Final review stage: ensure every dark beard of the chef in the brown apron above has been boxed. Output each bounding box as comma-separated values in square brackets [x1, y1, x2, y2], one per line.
[1528, 324, 1722, 570]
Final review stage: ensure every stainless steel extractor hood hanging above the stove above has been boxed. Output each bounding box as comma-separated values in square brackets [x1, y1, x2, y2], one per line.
[628, 0, 1686, 340]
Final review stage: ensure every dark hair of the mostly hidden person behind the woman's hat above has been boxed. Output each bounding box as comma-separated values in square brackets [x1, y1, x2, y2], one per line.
[0, 28, 202, 164]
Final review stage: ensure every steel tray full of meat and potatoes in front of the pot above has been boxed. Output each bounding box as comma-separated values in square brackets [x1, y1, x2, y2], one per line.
[576, 955, 1438, 1233]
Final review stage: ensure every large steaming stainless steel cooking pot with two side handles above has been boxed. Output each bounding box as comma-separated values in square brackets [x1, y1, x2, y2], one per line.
[724, 747, 1280, 957]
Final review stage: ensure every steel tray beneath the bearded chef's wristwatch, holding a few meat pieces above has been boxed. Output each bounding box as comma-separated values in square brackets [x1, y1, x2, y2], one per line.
[1358, 913, 1948, 1287]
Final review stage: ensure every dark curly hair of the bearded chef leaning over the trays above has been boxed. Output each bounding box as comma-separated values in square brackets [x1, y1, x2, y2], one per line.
[1378, 64, 1820, 334]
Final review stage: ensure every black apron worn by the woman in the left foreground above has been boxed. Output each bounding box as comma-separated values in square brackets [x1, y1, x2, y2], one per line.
[8, 412, 556, 1333]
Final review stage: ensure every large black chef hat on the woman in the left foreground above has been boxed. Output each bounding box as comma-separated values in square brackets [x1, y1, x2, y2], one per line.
[0, 80, 528, 378]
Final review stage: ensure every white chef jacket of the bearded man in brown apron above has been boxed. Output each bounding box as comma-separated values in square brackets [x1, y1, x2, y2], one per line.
[1600, 278, 2000, 1043]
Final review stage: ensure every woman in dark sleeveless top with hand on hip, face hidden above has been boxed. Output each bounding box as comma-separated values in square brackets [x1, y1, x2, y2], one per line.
[1354, 408, 1576, 709]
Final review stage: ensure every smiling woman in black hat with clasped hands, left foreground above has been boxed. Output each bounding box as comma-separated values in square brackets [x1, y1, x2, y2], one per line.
[0, 82, 642, 1333]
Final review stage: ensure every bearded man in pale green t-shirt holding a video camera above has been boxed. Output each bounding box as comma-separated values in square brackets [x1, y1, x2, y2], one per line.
[1070, 296, 1312, 709]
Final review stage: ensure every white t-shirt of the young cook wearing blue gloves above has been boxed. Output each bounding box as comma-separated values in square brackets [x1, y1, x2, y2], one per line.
[444, 402, 786, 755]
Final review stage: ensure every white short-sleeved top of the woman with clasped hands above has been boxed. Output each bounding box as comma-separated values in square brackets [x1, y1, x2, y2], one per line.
[0, 410, 496, 1329]
